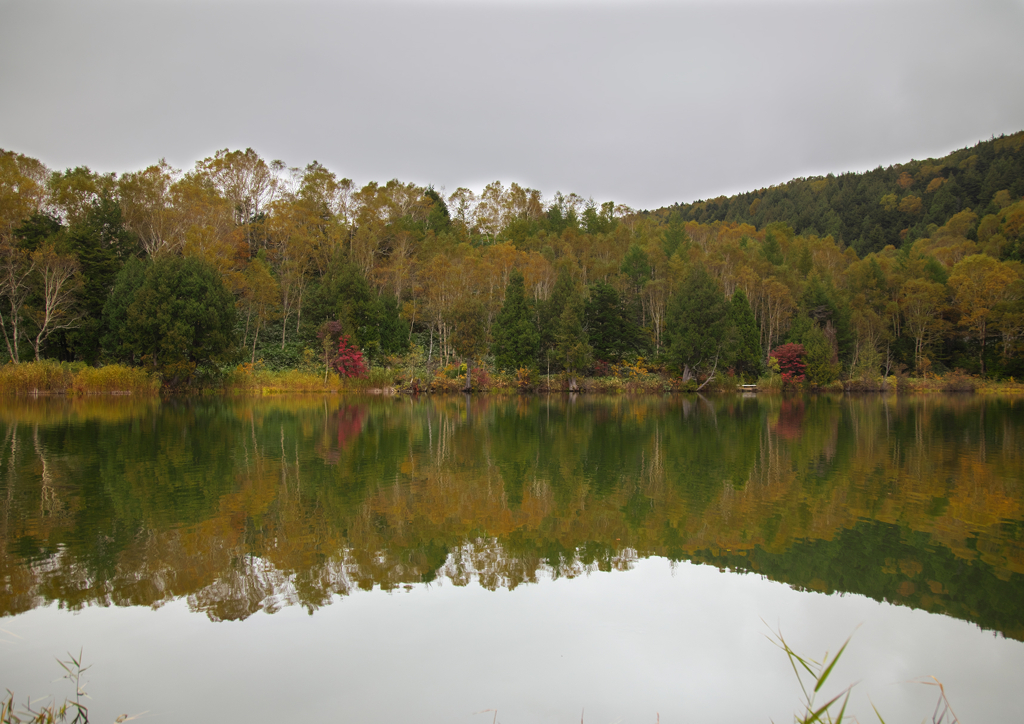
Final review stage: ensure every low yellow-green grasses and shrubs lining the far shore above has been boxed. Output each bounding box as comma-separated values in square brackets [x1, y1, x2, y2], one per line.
[0, 359, 1024, 396]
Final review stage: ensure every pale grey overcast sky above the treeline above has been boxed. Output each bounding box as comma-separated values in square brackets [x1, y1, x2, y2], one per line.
[0, 0, 1024, 208]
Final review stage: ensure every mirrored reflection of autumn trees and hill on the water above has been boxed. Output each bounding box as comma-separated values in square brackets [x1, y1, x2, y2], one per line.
[0, 396, 1024, 639]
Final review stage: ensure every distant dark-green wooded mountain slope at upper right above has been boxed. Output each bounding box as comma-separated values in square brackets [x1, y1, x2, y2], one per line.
[653, 131, 1024, 256]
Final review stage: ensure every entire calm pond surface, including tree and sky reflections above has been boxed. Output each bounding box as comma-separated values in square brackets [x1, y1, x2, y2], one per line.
[0, 395, 1024, 724]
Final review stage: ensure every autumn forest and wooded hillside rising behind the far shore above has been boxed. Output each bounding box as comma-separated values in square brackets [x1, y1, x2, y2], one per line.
[0, 131, 1024, 387]
